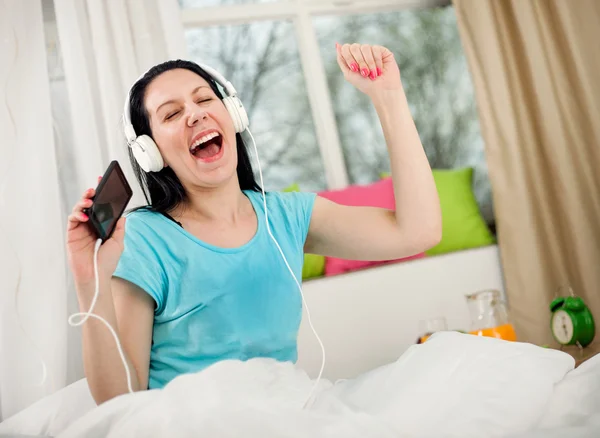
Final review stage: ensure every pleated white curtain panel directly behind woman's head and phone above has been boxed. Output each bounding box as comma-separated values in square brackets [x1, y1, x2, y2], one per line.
[54, 0, 186, 210]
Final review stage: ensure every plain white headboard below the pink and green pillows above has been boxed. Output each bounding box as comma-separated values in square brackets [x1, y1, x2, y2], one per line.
[298, 245, 504, 380]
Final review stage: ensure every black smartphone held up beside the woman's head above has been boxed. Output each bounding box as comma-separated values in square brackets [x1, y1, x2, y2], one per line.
[84, 161, 133, 243]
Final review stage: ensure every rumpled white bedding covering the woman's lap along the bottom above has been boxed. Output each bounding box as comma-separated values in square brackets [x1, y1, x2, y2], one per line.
[0, 332, 600, 438]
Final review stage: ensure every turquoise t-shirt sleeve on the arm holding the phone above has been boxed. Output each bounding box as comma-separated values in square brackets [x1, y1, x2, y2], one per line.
[113, 212, 167, 313]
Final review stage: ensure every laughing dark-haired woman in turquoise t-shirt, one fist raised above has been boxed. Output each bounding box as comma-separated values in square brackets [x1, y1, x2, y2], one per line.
[67, 44, 441, 403]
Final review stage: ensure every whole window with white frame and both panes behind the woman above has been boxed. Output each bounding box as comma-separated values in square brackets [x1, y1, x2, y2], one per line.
[180, 0, 494, 223]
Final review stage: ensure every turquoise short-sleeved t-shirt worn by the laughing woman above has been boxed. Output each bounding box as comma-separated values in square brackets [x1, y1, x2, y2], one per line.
[114, 191, 316, 389]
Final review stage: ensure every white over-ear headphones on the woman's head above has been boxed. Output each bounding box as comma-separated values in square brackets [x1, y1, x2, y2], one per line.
[123, 64, 250, 172]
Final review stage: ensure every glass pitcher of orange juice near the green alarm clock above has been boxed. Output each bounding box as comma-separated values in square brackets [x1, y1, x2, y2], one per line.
[466, 289, 517, 341]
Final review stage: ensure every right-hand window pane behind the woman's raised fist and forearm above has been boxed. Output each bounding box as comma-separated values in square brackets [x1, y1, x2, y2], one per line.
[313, 7, 492, 220]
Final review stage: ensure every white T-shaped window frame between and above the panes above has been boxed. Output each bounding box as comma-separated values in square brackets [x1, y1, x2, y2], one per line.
[178, 0, 451, 190]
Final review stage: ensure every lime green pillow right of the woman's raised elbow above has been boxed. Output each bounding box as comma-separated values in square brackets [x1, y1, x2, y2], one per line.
[425, 167, 496, 255]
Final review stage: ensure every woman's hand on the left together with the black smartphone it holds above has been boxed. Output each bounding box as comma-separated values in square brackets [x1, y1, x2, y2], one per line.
[67, 161, 132, 284]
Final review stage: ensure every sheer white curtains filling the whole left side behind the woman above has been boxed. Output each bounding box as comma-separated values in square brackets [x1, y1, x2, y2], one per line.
[0, 0, 186, 418]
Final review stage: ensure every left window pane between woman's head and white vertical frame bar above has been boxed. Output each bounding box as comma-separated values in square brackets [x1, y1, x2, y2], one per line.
[186, 21, 326, 191]
